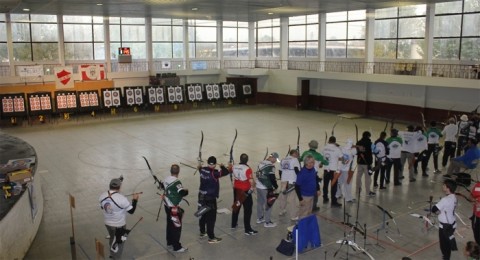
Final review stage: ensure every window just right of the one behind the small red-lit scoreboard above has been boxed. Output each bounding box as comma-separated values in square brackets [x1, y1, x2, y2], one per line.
[152, 18, 185, 59]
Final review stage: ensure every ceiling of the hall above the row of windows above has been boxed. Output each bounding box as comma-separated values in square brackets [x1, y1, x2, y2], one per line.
[0, 0, 456, 21]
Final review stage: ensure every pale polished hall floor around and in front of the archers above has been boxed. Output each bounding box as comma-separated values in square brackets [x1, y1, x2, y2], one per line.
[3, 106, 473, 260]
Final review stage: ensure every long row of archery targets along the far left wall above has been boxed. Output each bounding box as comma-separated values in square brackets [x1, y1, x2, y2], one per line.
[0, 83, 254, 124]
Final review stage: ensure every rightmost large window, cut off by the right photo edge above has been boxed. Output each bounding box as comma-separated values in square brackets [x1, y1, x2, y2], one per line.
[433, 0, 480, 61]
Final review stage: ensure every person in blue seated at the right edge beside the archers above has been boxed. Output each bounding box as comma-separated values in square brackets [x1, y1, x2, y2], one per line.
[447, 138, 480, 176]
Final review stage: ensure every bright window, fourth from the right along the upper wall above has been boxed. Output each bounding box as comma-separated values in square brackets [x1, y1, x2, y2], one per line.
[288, 14, 319, 57]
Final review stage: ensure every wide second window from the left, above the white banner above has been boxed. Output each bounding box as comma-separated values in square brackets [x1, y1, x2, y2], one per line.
[10, 14, 58, 61]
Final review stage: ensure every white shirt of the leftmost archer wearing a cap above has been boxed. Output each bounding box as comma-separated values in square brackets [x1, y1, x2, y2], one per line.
[98, 190, 132, 227]
